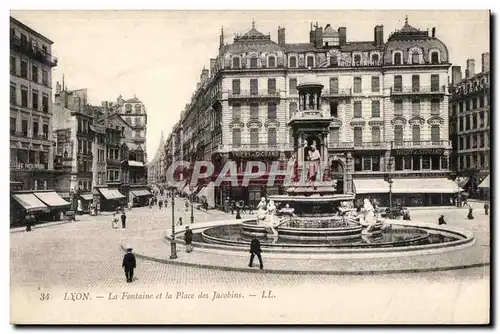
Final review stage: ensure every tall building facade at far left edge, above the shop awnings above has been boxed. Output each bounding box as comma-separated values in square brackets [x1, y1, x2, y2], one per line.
[10, 17, 57, 190]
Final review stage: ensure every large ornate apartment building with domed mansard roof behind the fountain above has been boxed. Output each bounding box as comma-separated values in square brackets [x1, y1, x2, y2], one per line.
[166, 20, 458, 205]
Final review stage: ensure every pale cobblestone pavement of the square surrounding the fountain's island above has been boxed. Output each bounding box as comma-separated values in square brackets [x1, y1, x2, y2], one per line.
[10, 200, 489, 289]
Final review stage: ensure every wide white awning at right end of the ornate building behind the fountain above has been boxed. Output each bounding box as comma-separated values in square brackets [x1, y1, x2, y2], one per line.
[392, 178, 463, 194]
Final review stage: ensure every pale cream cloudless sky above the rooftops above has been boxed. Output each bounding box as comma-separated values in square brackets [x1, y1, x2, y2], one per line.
[11, 10, 490, 160]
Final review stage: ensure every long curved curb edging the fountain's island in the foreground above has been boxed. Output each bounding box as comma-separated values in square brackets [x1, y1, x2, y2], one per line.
[120, 245, 490, 276]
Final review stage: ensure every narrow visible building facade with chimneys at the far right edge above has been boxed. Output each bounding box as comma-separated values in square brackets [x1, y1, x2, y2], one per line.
[450, 53, 491, 197]
